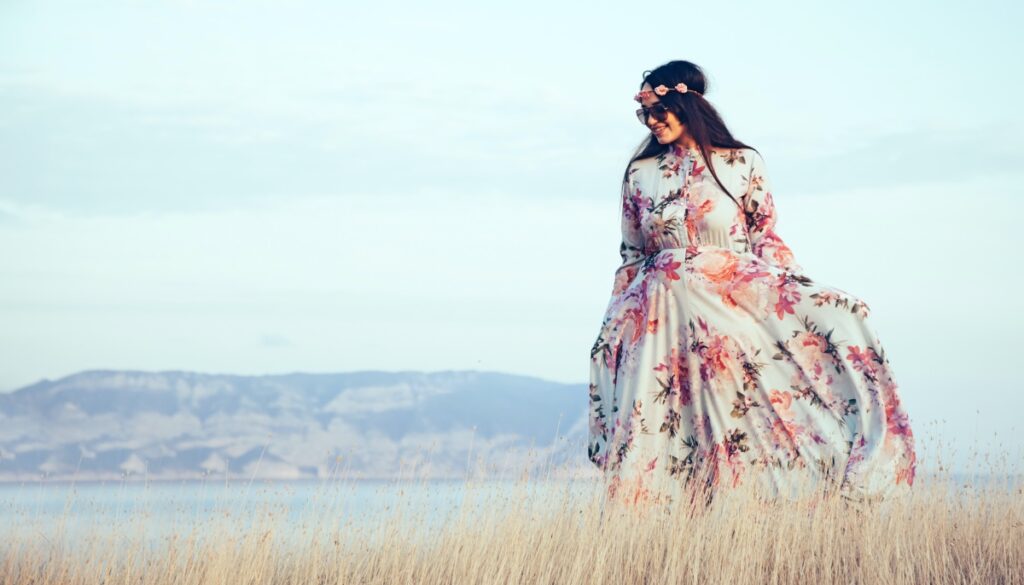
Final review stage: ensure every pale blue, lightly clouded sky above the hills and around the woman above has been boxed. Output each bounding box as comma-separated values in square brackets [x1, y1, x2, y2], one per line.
[0, 0, 1024, 467]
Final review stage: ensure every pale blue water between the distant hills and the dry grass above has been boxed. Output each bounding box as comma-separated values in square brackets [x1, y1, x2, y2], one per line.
[0, 474, 1024, 546]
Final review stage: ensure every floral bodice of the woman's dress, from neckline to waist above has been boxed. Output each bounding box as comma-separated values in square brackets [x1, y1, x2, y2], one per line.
[629, 144, 752, 255]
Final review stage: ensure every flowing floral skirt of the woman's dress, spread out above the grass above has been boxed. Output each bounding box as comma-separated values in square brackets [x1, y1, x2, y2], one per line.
[588, 246, 915, 501]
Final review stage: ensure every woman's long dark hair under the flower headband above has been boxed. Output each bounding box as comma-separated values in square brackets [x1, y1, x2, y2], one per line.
[623, 60, 756, 207]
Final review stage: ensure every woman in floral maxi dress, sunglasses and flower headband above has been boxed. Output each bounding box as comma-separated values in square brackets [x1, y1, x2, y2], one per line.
[588, 60, 915, 508]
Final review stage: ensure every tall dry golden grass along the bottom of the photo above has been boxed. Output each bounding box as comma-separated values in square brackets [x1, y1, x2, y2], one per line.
[0, 436, 1024, 585]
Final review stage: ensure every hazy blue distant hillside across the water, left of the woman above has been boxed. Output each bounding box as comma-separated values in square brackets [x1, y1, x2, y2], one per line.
[0, 371, 593, 482]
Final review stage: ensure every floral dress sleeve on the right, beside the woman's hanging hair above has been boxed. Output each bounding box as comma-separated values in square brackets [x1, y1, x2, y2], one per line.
[743, 151, 804, 274]
